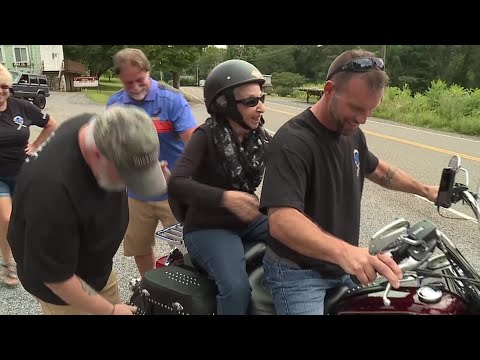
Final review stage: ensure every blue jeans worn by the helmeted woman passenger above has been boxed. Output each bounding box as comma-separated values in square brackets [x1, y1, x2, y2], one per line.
[185, 215, 268, 315]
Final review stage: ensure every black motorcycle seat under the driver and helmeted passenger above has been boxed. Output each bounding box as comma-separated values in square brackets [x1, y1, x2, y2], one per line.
[250, 266, 348, 315]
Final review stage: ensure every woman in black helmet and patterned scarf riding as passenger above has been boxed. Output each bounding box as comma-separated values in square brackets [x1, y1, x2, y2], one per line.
[168, 60, 271, 315]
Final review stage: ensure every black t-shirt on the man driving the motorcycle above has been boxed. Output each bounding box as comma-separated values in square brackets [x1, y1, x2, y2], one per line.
[260, 109, 378, 276]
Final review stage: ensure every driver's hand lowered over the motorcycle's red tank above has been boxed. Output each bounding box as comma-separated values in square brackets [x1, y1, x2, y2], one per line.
[339, 245, 403, 289]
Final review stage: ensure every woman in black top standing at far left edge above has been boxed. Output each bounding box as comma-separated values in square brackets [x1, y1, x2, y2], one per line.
[0, 64, 56, 286]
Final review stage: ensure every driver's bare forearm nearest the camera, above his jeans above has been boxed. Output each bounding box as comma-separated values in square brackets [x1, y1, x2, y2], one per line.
[268, 208, 349, 264]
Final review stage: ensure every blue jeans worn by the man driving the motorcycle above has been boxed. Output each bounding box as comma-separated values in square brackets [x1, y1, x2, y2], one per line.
[263, 251, 356, 315]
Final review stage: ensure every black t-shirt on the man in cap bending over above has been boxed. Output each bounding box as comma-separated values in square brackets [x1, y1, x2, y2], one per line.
[7, 114, 128, 305]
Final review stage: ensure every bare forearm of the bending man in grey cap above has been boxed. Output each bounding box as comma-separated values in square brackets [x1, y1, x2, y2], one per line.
[45, 275, 114, 315]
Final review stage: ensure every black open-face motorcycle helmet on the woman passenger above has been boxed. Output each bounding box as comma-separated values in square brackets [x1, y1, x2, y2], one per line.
[203, 59, 265, 129]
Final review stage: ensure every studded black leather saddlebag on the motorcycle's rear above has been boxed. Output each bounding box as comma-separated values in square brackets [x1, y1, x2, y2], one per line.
[130, 265, 217, 315]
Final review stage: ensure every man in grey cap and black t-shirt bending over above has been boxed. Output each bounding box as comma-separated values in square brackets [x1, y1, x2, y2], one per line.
[7, 106, 169, 315]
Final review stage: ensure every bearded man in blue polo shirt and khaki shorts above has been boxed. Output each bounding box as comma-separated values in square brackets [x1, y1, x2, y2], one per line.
[107, 48, 197, 277]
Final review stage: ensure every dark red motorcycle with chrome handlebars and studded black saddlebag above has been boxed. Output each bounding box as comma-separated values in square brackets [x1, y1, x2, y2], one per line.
[130, 155, 480, 315]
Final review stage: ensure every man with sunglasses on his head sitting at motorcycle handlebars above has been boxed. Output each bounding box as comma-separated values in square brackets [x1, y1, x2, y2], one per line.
[260, 50, 438, 314]
